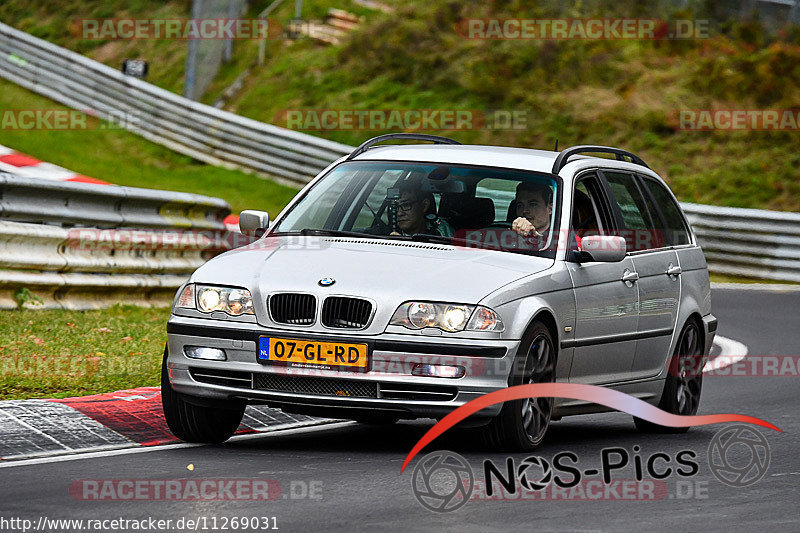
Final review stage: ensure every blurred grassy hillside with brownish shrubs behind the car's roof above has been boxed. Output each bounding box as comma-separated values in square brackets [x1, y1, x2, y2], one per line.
[223, 0, 800, 211]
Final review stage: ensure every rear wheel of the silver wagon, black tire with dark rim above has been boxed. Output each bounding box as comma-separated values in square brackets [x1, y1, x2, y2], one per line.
[633, 320, 705, 433]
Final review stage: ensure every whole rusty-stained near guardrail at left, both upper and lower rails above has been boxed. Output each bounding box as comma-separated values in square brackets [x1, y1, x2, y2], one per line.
[0, 173, 238, 309]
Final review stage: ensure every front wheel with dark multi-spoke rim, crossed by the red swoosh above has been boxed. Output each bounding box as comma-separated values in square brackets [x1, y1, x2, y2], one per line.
[481, 322, 557, 452]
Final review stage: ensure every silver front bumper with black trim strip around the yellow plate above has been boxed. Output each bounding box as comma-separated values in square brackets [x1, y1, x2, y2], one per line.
[167, 315, 520, 418]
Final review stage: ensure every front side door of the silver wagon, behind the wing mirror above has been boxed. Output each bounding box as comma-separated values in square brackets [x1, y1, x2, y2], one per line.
[568, 173, 639, 384]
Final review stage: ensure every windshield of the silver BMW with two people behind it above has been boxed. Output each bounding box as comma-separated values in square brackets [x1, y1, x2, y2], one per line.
[274, 162, 559, 257]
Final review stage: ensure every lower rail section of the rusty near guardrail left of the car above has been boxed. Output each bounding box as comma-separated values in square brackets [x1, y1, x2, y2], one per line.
[0, 220, 251, 309]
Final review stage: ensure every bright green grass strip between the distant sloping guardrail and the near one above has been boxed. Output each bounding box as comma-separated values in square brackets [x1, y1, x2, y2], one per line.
[0, 80, 297, 216]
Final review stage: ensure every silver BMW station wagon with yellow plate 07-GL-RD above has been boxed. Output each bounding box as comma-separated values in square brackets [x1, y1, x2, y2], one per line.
[161, 134, 717, 451]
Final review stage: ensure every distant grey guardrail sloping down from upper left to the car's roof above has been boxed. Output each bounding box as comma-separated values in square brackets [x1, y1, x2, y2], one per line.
[0, 23, 352, 185]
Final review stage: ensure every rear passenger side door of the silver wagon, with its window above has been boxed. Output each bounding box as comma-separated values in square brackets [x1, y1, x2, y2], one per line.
[602, 171, 681, 378]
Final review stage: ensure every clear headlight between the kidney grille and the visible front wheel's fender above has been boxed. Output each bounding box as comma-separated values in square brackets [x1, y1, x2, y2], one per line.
[389, 302, 503, 332]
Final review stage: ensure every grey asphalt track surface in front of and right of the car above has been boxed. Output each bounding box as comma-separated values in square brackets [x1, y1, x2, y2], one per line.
[0, 290, 800, 533]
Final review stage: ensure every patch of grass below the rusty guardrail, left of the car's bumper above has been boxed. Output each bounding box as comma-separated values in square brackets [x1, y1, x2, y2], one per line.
[0, 306, 169, 400]
